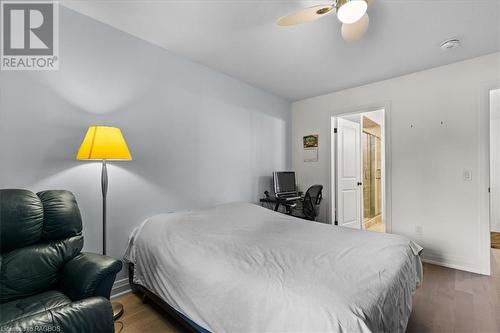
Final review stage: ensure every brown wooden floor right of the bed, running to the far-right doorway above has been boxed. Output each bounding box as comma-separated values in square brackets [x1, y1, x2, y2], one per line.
[407, 250, 500, 333]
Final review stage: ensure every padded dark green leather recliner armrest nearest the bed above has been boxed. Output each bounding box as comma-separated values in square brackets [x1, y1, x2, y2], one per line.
[60, 252, 123, 301]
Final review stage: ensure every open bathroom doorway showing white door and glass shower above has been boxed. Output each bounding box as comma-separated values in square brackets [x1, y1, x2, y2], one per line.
[331, 109, 387, 232]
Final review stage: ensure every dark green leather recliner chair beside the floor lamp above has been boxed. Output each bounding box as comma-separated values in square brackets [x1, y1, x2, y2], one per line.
[0, 189, 122, 332]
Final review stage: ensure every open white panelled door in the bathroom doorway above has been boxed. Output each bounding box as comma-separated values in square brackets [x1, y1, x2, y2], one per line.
[336, 118, 362, 229]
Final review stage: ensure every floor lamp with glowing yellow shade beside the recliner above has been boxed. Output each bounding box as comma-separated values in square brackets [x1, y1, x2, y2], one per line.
[76, 126, 132, 320]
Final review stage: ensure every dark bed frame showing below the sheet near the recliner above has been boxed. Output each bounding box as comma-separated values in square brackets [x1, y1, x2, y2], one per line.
[128, 263, 205, 333]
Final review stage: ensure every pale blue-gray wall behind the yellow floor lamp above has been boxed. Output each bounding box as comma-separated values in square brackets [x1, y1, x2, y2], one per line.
[0, 7, 291, 278]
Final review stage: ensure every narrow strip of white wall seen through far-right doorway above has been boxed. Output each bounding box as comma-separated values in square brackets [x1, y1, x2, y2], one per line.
[490, 89, 500, 232]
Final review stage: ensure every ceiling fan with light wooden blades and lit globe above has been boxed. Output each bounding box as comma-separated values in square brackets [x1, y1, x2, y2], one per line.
[276, 0, 372, 42]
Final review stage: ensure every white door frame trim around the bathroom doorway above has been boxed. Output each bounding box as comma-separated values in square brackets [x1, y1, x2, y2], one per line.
[328, 101, 392, 233]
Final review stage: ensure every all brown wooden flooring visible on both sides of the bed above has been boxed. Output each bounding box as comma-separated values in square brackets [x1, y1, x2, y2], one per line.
[115, 250, 500, 333]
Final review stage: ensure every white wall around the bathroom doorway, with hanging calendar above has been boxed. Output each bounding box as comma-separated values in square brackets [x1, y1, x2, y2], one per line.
[292, 53, 500, 273]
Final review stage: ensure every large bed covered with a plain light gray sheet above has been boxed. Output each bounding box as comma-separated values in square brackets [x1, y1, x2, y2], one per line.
[125, 203, 422, 333]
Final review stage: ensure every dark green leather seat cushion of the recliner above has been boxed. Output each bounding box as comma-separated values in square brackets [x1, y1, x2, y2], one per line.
[0, 290, 71, 325]
